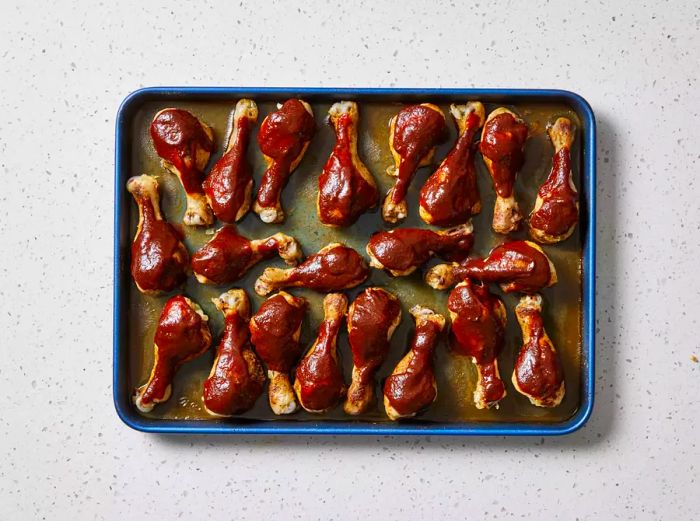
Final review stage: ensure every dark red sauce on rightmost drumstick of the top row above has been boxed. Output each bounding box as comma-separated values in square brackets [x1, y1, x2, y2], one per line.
[530, 147, 578, 236]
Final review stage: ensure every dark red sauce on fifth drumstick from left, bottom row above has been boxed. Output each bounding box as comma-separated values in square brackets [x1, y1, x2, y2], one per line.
[348, 288, 401, 384]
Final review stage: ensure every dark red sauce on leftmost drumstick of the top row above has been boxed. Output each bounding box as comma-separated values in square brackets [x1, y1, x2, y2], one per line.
[151, 109, 214, 194]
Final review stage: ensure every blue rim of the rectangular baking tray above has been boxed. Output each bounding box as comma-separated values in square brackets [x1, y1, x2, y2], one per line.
[113, 87, 596, 436]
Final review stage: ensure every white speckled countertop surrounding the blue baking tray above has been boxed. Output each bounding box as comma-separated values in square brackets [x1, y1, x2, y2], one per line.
[0, 0, 700, 519]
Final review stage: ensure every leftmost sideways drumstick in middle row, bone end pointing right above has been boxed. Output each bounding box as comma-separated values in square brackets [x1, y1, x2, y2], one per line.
[192, 224, 302, 285]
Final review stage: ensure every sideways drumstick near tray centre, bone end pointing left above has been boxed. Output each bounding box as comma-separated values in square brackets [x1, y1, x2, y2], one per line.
[255, 242, 369, 296]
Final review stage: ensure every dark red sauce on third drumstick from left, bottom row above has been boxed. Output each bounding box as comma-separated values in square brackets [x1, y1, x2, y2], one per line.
[251, 295, 306, 373]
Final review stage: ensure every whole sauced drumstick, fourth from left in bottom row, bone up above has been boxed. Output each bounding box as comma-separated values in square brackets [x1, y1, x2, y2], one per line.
[294, 293, 348, 413]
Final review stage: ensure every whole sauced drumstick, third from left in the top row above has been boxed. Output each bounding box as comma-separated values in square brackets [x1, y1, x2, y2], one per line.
[253, 99, 316, 223]
